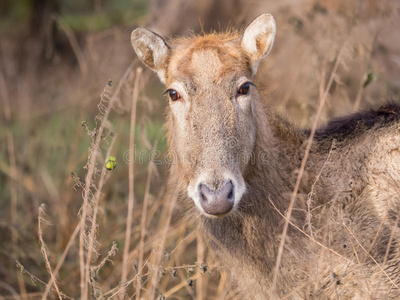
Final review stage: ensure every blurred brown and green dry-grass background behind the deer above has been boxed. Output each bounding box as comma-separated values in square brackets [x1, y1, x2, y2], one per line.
[0, 0, 400, 299]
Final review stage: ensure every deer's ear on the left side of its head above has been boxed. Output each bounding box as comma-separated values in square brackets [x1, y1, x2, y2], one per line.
[131, 28, 170, 84]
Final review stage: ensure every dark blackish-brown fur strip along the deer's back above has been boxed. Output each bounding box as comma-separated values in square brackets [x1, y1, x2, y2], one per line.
[312, 103, 400, 142]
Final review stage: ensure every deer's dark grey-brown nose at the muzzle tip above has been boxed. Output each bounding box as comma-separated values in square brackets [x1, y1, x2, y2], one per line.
[199, 180, 235, 215]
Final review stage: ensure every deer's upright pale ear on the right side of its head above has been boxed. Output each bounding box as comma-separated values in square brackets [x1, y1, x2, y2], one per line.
[242, 14, 276, 74]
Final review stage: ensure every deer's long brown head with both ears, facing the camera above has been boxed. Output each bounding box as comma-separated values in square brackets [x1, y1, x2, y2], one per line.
[132, 14, 275, 216]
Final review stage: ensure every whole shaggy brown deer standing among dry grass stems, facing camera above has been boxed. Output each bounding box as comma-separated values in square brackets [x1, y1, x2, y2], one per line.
[131, 14, 400, 299]
